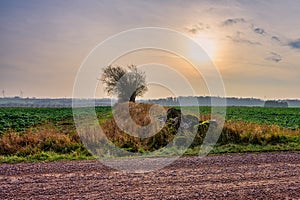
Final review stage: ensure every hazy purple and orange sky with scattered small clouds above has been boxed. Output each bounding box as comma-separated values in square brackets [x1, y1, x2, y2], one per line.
[0, 0, 300, 99]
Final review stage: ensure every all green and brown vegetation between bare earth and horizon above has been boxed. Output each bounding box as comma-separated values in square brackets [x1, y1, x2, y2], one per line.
[0, 104, 300, 163]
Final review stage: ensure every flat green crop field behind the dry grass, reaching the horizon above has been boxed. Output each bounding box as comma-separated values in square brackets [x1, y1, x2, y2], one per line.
[0, 107, 300, 134]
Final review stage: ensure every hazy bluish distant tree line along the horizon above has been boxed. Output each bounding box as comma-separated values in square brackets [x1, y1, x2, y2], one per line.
[0, 96, 300, 107]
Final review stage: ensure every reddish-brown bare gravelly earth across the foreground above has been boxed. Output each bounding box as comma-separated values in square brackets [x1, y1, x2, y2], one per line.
[0, 152, 300, 199]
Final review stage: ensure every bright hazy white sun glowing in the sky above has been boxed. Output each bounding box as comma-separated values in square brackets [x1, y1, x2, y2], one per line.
[189, 36, 217, 62]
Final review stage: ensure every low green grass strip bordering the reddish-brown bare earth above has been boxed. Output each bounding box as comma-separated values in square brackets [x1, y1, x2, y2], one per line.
[0, 128, 300, 163]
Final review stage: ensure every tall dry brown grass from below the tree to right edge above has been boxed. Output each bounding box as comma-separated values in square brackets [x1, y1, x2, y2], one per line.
[102, 104, 300, 152]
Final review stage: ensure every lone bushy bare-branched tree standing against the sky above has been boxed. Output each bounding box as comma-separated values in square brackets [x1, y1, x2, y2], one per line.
[100, 65, 148, 102]
